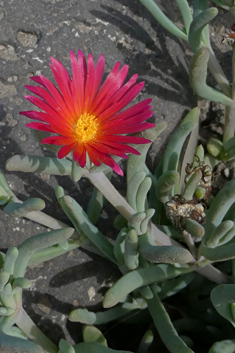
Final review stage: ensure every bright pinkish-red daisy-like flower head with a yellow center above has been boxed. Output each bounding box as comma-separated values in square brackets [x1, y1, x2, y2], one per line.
[20, 50, 154, 175]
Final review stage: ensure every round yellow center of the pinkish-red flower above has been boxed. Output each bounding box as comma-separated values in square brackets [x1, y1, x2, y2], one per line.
[75, 113, 99, 142]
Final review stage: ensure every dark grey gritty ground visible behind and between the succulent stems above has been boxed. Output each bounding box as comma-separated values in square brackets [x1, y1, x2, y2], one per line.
[0, 0, 233, 349]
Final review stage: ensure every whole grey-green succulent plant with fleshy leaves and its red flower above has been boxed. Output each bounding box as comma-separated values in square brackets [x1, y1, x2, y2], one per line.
[0, 0, 235, 353]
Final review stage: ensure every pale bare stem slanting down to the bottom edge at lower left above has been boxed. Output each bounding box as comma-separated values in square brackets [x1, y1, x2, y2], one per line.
[16, 308, 59, 353]
